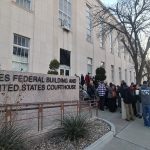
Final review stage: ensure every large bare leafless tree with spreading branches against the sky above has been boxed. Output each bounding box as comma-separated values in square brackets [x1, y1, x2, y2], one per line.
[93, 0, 150, 83]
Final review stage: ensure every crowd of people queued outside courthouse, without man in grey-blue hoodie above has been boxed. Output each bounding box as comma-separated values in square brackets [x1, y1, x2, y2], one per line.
[80, 74, 146, 121]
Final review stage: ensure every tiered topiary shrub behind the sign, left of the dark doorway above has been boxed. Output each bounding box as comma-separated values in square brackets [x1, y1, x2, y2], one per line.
[48, 59, 59, 75]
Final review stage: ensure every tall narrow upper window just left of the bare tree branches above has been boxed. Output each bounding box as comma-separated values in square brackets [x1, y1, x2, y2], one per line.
[86, 5, 92, 42]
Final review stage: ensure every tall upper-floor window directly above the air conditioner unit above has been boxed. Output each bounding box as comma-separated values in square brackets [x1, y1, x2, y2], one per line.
[59, 0, 72, 29]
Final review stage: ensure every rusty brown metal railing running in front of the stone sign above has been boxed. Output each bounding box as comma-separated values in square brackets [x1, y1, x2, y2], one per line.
[0, 100, 98, 131]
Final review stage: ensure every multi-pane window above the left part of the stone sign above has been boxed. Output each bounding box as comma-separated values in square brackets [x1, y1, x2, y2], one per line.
[12, 34, 30, 71]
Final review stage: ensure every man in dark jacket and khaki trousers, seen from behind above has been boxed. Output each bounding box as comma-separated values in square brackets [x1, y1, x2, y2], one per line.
[124, 85, 134, 121]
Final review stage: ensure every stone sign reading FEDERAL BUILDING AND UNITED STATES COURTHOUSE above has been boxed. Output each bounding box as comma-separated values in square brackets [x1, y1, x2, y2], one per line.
[0, 70, 79, 104]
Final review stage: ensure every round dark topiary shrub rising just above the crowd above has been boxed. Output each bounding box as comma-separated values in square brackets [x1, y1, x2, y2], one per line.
[95, 67, 106, 83]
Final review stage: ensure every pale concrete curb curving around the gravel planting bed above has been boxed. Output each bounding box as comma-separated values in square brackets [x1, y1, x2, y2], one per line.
[84, 117, 116, 150]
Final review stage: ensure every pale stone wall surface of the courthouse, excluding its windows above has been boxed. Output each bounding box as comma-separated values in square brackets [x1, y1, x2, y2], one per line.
[0, 0, 135, 84]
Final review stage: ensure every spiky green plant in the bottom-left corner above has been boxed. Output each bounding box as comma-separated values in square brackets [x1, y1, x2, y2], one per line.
[0, 124, 27, 150]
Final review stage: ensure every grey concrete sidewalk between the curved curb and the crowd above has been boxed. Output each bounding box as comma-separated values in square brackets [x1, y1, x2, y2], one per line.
[98, 110, 150, 150]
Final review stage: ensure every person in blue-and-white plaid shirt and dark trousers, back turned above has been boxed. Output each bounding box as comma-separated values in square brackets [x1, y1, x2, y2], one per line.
[97, 81, 106, 111]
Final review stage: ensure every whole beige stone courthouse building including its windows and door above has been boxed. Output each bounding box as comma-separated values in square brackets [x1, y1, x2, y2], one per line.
[0, 0, 135, 84]
